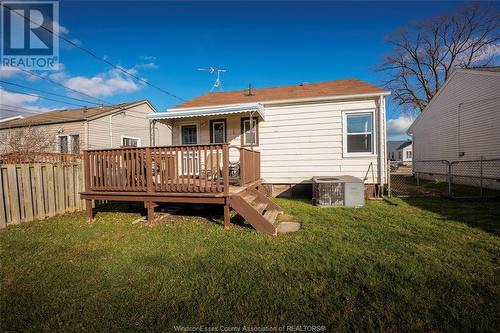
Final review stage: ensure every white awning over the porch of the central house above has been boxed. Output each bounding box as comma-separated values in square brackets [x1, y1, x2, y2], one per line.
[146, 103, 265, 120]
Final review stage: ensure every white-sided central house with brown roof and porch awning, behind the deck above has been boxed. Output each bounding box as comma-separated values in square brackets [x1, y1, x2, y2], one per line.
[148, 79, 389, 194]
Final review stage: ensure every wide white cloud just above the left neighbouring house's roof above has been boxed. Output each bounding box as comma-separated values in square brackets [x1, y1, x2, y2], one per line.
[63, 70, 141, 97]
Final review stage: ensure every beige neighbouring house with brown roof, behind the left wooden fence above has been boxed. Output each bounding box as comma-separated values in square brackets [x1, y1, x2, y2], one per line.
[0, 100, 171, 154]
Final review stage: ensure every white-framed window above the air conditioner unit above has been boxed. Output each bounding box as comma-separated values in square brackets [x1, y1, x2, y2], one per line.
[343, 112, 374, 156]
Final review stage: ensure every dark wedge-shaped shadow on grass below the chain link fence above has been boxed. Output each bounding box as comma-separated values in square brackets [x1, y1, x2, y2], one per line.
[402, 197, 500, 236]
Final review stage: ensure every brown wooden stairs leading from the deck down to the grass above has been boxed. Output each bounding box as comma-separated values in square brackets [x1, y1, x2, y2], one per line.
[229, 188, 283, 235]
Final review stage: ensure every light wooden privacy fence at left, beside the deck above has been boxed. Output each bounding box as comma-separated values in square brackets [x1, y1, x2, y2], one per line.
[0, 161, 84, 228]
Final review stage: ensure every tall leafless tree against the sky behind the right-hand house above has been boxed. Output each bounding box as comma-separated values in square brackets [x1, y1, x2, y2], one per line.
[380, 3, 500, 112]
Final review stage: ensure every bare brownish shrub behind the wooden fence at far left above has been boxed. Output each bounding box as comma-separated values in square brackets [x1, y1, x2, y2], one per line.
[0, 126, 55, 157]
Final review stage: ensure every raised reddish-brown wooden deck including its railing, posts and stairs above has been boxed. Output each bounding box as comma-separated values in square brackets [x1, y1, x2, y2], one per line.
[81, 144, 279, 234]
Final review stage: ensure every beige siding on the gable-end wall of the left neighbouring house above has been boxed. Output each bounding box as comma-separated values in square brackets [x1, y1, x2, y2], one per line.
[88, 103, 172, 149]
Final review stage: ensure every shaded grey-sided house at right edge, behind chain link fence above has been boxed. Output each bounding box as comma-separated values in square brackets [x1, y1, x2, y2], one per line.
[408, 67, 500, 188]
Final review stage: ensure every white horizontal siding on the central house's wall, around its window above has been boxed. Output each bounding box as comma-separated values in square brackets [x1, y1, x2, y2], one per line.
[259, 100, 385, 184]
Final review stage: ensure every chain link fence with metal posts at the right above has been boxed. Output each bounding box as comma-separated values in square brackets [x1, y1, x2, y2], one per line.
[388, 159, 500, 199]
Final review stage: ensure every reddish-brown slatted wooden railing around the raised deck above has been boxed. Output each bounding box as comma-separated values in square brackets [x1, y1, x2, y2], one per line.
[84, 144, 260, 194]
